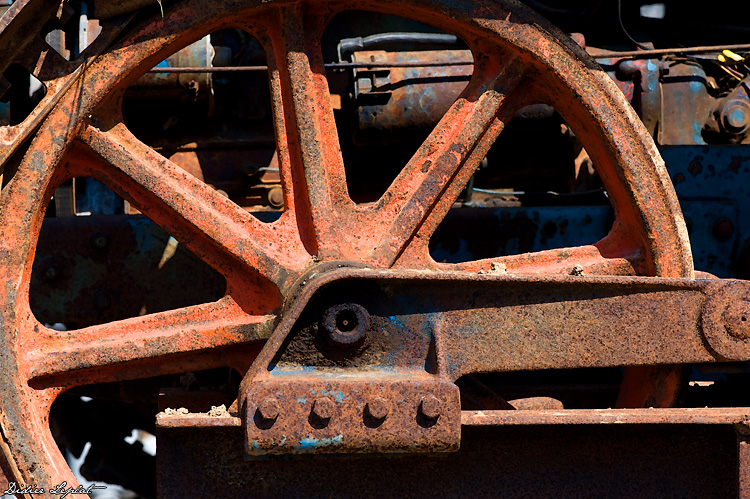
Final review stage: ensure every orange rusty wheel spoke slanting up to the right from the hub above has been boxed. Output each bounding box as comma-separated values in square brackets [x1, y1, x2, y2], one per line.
[375, 58, 525, 265]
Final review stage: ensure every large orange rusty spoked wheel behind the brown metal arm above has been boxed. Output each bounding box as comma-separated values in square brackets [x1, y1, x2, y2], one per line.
[0, 0, 692, 492]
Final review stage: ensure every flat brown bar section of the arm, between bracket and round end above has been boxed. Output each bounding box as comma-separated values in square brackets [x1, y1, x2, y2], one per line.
[440, 281, 716, 379]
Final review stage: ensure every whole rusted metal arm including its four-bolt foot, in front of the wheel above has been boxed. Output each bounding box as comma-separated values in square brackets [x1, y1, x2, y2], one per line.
[238, 264, 750, 455]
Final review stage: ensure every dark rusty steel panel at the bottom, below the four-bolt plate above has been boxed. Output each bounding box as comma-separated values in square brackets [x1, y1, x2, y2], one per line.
[157, 424, 738, 498]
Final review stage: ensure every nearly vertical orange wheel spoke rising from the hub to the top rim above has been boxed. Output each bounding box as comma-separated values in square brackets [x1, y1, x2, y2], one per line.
[267, 7, 352, 258]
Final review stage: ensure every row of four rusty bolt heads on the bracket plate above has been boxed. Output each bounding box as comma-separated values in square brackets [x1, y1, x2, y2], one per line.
[258, 395, 442, 421]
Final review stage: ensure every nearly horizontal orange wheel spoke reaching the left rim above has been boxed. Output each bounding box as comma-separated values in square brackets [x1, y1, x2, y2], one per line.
[26, 297, 274, 384]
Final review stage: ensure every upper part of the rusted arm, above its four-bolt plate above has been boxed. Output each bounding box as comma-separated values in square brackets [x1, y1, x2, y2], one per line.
[257, 269, 750, 380]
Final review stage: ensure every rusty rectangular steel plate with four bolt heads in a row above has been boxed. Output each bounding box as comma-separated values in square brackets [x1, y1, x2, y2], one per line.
[244, 373, 461, 456]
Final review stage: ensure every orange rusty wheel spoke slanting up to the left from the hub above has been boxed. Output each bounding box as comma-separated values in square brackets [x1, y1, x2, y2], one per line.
[81, 124, 309, 292]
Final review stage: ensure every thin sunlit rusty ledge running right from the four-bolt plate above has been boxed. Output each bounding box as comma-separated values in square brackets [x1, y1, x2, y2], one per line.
[461, 407, 750, 426]
